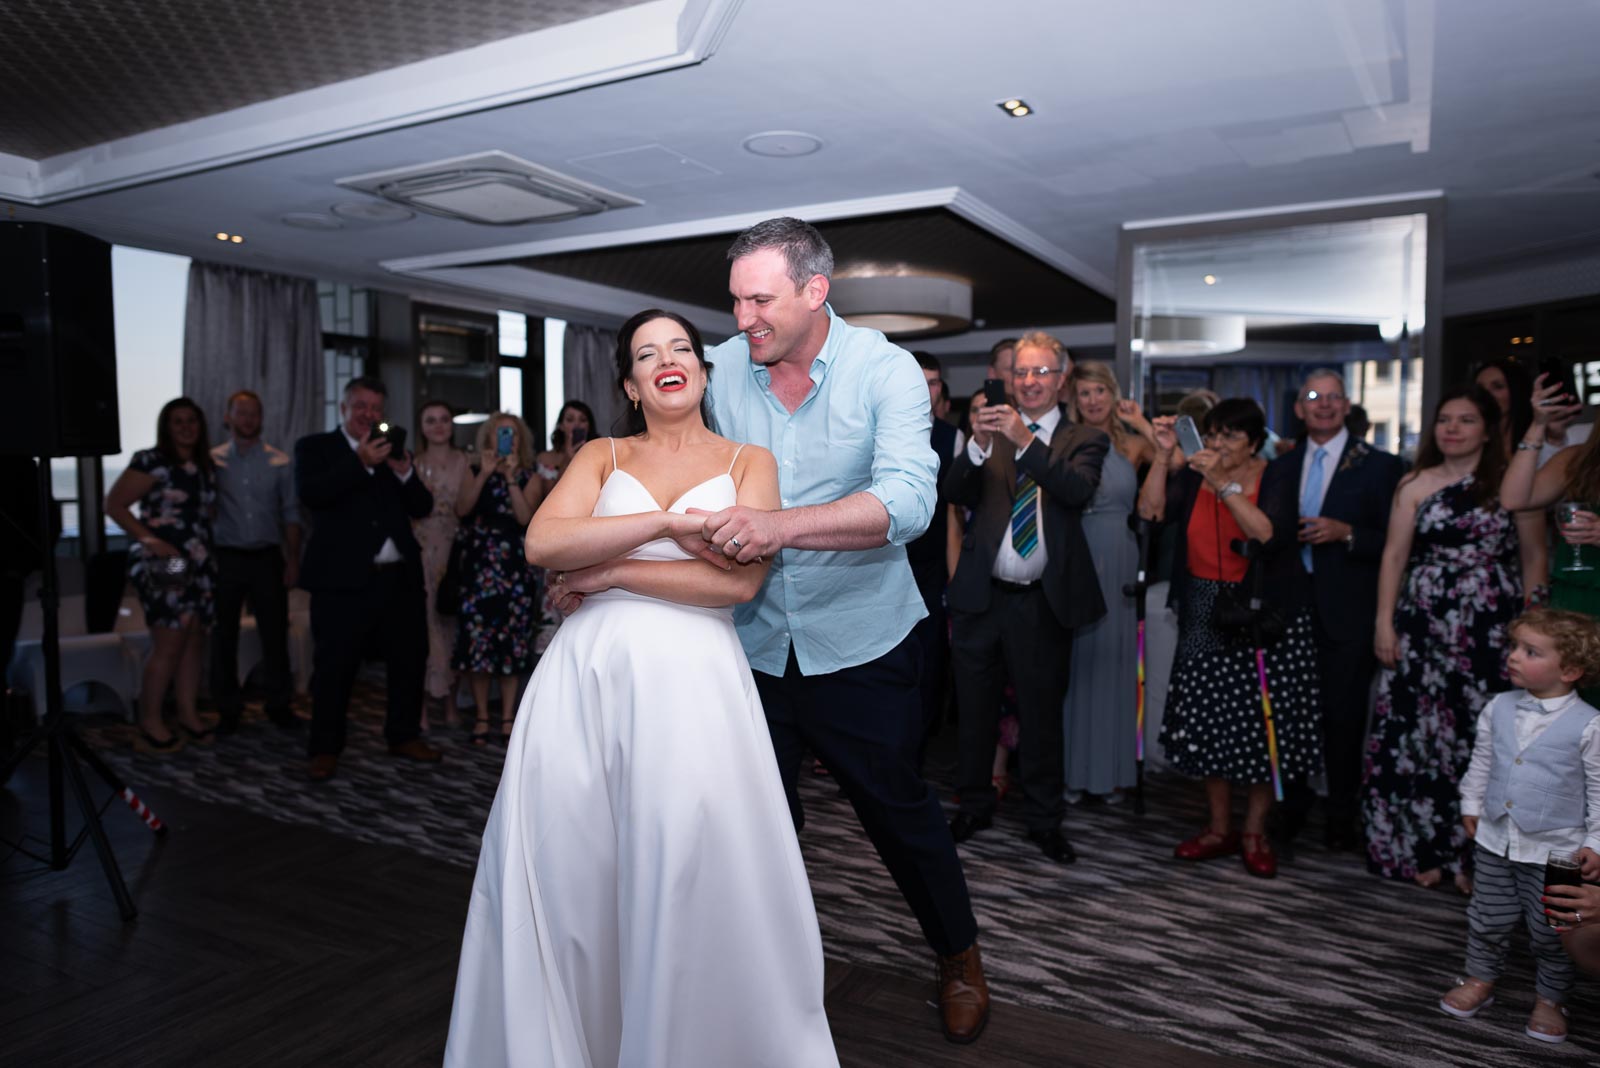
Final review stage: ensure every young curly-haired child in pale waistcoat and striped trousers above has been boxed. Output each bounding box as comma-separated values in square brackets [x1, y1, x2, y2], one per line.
[1438, 608, 1600, 1042]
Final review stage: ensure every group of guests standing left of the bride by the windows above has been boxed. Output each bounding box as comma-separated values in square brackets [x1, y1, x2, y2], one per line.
[106, 377, 594, 780]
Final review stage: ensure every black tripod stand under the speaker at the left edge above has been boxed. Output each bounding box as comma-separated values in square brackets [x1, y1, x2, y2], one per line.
[0, 457, 166, 921]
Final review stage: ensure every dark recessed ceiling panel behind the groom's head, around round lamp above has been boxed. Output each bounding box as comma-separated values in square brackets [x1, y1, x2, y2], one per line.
[515, 208, 1117, 329]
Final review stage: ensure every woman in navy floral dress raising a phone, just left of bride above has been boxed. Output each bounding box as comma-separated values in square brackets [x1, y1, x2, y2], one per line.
[451, 412, 544, 745]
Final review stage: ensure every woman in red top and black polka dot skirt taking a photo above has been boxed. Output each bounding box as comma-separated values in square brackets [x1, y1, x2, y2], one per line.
[1139, 397, 1322, 878]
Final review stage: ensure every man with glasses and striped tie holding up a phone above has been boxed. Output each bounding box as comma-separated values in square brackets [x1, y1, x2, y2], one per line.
[944, 333, 1110, 863]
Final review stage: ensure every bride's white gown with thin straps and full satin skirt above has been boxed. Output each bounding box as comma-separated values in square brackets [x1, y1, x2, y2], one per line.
[445, 472, 838, 1068]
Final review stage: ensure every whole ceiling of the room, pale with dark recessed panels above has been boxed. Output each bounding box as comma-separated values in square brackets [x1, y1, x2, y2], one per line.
[0, 0, 1600, 344]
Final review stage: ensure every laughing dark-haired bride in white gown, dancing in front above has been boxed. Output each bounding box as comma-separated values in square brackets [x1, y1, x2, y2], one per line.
[445, 310, 838, 1068]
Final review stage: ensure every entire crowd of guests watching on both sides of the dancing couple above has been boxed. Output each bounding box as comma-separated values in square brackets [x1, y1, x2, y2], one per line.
[107, 333, 1600, 1041]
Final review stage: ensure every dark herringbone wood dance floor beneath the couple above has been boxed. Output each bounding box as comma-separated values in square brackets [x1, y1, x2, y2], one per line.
[0, 759, 1246, 1068]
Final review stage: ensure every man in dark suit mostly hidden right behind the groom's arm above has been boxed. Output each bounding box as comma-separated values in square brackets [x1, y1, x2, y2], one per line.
[906, 352, 962, 742]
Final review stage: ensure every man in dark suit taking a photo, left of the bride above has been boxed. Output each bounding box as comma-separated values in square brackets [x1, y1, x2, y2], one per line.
[294, 377, 438, 780]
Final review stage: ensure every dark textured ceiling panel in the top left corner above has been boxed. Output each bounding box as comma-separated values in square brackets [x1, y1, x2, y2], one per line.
[0, 0, 642, 160]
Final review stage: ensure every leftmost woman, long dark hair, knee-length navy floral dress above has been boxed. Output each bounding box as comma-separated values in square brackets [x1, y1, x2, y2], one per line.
[106, 397, 216, 753]
